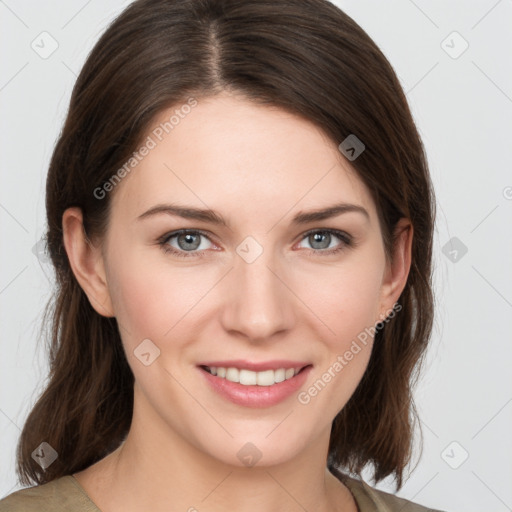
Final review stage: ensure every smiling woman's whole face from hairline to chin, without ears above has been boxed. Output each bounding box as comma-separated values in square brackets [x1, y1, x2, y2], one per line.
[71, 94, 408, 466]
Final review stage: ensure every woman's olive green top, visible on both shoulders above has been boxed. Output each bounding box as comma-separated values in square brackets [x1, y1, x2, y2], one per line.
[0, 475, 442, 512]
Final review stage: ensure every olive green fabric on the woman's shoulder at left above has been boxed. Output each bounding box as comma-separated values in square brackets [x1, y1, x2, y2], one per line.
[0, 475, 99, 512]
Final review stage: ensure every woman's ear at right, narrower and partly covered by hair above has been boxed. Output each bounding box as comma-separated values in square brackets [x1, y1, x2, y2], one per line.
[378, 218, 413, 321]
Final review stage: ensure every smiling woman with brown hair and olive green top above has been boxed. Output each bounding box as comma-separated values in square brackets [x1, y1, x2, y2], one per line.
[0, 0, 444, 512]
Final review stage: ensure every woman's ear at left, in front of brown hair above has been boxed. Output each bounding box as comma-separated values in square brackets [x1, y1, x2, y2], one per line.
[62, 207, 115, 317]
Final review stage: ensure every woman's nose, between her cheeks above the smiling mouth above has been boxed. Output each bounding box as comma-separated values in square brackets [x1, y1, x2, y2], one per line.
[221, 245, 299, 342]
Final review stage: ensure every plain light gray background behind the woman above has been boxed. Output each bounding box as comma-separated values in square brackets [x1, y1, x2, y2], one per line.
[0, 0, 512, 512]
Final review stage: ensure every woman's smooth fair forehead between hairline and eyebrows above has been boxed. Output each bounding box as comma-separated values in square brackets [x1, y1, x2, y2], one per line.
[113, 94, 376, 224]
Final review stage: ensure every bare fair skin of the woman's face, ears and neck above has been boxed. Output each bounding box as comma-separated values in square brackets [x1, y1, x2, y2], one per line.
[63, 93, 412, 512]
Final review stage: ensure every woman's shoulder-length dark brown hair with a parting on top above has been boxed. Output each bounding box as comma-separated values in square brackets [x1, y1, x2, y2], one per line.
[17, 0, 435, 488]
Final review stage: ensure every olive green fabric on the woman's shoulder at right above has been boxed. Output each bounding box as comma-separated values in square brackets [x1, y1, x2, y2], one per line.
[334, 473, 445, 512]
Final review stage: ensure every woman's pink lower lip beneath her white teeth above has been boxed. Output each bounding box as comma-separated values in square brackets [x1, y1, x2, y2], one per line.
[198, 365, 312, 408]
